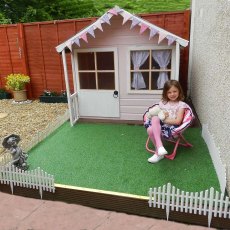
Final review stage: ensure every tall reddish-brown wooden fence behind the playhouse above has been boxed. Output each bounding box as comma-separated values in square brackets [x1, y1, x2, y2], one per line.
[0, 10, 190, 98]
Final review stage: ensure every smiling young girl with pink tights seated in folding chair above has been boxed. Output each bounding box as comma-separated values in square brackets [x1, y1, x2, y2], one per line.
[147, 80, 187, 163]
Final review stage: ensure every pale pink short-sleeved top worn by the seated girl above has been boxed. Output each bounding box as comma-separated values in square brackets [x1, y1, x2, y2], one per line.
[159, 101, 187, 119]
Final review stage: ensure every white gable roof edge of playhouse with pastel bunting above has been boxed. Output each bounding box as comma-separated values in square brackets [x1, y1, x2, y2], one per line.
[56, 6, 188, 53]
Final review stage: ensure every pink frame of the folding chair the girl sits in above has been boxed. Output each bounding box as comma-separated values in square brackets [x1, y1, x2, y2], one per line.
[143, 104, 195, 160]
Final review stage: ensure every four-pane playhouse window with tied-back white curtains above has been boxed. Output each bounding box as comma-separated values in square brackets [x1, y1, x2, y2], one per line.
[130, 49, 172, 90]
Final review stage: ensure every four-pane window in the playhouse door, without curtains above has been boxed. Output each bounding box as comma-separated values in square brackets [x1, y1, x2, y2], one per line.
[77, 51, 115, 90]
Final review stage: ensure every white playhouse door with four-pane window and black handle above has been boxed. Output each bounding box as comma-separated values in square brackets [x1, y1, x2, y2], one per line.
[76, 48, 119, 118]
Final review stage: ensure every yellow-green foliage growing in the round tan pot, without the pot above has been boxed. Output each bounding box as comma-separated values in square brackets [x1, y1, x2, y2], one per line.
[6, 73, 30, 91]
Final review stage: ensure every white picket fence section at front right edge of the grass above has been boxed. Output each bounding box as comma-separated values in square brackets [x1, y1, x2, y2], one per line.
[149, 183, 230, 227]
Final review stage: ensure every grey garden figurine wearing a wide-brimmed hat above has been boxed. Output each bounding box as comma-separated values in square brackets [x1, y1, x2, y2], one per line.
[2, 134, 29, 170]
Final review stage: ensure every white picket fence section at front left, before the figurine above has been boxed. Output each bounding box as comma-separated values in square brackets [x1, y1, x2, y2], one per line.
[0, 164, 55, 199]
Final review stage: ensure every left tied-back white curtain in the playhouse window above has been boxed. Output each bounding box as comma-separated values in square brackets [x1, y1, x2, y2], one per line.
[131, 51, 149, 89]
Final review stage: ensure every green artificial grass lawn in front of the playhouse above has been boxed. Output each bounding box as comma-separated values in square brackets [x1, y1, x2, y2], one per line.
[28, 122, 220, 196]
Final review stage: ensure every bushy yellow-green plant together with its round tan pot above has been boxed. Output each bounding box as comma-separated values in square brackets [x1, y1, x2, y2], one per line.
[6, 73, 30, 102]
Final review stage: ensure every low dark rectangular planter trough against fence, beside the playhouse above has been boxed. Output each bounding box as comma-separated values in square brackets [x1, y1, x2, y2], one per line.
[39, 90, 68, 103]
